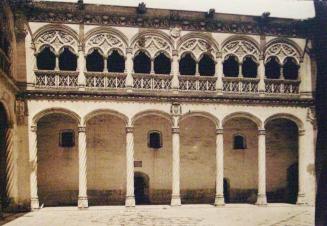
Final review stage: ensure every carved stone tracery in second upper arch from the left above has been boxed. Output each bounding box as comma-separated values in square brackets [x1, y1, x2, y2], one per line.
[85, 32, 126, 56]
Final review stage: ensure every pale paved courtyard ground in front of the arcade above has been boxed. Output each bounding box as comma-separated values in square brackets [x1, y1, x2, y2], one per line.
[6, 204, 314, 226]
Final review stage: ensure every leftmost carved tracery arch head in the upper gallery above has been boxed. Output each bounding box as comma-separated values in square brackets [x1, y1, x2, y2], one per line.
[33, 24, 79, 55]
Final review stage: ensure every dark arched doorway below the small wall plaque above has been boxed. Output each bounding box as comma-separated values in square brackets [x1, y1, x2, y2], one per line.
[134, 173, 150, 205]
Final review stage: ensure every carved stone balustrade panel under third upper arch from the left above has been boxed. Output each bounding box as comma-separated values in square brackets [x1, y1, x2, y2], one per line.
[133, 73, 173, 90]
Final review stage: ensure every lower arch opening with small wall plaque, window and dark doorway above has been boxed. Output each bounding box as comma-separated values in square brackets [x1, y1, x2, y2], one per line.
[133, 113, 172, 204]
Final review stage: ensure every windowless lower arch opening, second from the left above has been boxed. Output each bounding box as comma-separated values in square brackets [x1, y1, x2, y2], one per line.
[86, 113, 126, 206]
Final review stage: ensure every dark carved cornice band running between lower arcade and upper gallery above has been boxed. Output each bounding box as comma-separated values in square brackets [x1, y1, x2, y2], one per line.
[17, 90, 314, 107]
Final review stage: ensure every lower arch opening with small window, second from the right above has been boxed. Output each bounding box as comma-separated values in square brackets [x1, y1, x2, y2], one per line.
[223, 117, 258, 204]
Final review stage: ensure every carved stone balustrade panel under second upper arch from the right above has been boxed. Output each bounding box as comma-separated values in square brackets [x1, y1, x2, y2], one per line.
[223, 77, 260, 94]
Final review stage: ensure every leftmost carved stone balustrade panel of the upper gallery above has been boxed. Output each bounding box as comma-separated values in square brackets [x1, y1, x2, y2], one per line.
[35, 70, 78, 88]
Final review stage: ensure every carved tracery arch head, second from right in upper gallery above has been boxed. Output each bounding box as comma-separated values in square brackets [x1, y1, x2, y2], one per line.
[222, 35, 260, 62]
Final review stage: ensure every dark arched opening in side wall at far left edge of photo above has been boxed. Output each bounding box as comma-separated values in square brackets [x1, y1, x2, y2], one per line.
[0, 103, 9, 212]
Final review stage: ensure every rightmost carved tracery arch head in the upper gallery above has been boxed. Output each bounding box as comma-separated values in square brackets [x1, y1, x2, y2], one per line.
[264, 38, 303, 64]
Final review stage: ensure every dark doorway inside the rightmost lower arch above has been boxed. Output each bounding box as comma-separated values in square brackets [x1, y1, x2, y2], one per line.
[286, 163, 299, 204]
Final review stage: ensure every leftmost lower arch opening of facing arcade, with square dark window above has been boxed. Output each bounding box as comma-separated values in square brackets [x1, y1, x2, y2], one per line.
[37, 112, 79, 206]
